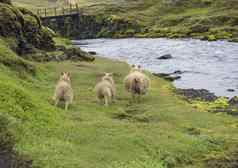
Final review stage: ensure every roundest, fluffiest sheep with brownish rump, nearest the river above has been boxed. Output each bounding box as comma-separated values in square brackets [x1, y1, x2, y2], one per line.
[124, 65, 150, 99]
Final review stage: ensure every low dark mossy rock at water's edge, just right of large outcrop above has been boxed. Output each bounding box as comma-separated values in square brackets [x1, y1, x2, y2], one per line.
[65, 47, 95, 61]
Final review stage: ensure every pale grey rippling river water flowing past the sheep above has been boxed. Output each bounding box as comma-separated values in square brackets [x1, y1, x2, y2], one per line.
[74, 38, 238, 97]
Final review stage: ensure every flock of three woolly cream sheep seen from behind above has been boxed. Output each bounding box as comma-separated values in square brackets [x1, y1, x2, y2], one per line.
[53, 65, 150, 110]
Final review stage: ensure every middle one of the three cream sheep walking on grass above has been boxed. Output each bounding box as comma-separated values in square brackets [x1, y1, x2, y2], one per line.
[95, 73, 116, 106]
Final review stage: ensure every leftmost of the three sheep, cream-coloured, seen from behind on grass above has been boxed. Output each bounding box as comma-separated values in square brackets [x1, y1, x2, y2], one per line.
[53, 72, 74, 110]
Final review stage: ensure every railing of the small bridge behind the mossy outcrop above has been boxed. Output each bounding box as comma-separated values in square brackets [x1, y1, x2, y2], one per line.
[36, 4, 79, 17]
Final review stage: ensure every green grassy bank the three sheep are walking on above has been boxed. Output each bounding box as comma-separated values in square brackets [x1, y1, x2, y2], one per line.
[0, 39, 238, 168]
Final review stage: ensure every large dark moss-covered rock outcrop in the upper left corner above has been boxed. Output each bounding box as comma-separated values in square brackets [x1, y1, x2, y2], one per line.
[0, 3, 55, 55]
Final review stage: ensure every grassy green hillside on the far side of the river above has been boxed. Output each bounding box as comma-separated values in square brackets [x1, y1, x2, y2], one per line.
[15, 0, 238, 41]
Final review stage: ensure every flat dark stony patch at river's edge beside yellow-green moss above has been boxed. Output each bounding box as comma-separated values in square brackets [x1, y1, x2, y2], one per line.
[176, 89, 218, 101]
